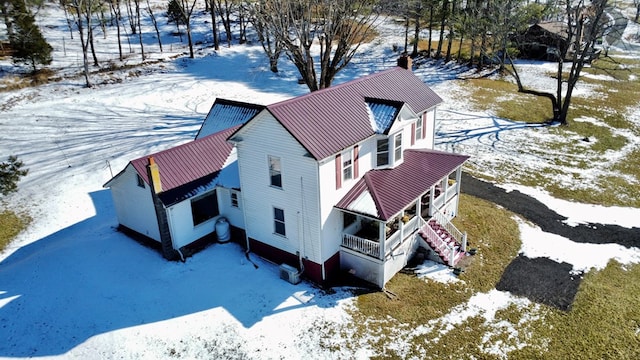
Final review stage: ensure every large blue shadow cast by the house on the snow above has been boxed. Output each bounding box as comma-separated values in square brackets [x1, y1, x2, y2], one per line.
[0, 190, 346, 357]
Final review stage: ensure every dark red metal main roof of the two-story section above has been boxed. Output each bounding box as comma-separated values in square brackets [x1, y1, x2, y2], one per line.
[267, 67, 442, 160]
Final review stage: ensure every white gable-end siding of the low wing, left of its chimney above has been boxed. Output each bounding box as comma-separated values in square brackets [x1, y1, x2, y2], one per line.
[111, 164, 160, 241]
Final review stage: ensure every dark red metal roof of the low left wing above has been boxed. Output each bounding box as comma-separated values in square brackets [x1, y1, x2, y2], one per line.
[131, 125, 240, 192]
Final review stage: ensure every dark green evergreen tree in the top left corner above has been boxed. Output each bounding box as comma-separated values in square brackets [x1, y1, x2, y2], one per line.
[9, 0, 53, 72]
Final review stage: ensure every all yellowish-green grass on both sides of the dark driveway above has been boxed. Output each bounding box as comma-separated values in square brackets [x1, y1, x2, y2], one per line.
[350, 54, 640, 359]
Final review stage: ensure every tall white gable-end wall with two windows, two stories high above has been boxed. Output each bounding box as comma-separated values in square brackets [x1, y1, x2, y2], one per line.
[236, 111, 324, 263]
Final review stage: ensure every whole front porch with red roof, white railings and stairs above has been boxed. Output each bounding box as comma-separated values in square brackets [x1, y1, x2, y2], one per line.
[335, 149, 468, 288]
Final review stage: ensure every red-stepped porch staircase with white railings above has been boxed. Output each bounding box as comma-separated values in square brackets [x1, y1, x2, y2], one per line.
[418, 218, 466, 267]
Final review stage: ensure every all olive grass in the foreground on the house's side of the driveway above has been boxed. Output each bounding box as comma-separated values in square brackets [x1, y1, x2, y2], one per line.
[348, 194, 640, 360]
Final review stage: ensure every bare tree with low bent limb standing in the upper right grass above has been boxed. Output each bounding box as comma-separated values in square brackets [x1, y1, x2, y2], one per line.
[505, 0, 608, 124]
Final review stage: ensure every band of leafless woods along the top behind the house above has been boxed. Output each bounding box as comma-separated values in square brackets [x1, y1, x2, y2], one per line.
[0, 0, 640, 122]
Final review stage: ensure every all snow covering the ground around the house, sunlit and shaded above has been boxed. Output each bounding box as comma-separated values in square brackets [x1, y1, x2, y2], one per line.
[0, 3, 640, 359]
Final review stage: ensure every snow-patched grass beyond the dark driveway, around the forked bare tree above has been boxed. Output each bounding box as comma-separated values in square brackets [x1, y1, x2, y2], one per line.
[462, 58, 640, 207]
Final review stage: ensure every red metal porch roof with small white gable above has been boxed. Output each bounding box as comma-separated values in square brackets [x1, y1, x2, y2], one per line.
[335, 149, 469, 221]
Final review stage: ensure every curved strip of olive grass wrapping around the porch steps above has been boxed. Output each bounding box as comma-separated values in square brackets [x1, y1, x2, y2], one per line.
[353, 194, 520, 351]
